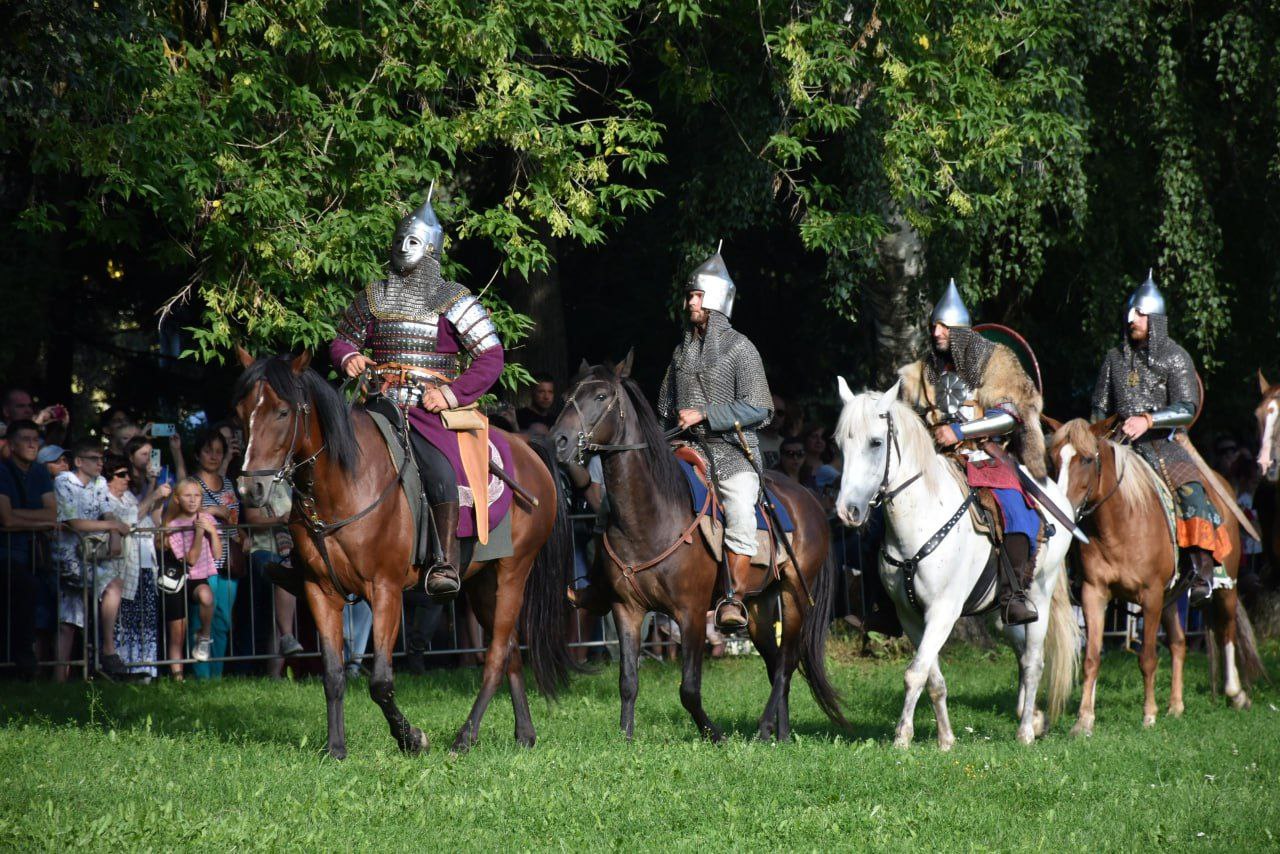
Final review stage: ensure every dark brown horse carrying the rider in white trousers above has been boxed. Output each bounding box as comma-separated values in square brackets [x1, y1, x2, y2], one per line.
[550, 355, 847, 741]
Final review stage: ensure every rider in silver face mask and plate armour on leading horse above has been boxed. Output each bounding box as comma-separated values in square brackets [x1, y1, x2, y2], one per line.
[329, 192, 509, 597]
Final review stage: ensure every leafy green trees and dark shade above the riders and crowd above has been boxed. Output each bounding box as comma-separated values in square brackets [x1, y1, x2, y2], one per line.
[0, 0, 1280, 437]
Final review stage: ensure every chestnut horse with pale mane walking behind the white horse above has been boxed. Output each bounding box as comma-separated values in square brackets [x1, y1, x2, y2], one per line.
[1048, 419, 1263, 735]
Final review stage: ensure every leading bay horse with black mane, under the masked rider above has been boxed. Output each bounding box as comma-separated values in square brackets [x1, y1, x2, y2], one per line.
[233, 350, 572, 759]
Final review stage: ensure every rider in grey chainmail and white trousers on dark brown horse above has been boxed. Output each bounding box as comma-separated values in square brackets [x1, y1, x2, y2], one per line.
[658, 252, 773, 631]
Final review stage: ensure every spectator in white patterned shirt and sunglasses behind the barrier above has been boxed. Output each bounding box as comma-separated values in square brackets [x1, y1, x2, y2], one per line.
[54, 440, 129, 681]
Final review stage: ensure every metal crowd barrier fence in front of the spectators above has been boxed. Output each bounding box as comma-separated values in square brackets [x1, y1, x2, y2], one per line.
[0, 513, 1204, 679]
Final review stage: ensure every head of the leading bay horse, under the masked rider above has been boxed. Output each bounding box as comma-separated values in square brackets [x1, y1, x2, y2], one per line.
[233, 347, 323, 507]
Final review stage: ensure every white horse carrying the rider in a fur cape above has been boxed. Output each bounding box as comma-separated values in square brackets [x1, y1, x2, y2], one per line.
[836, 376, 1080, 750]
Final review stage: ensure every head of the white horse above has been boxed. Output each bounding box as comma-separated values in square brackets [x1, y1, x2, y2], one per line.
[836, 376, 902, 528]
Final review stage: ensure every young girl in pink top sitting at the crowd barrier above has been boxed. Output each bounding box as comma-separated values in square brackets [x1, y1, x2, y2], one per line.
[165, 478, 223, 672]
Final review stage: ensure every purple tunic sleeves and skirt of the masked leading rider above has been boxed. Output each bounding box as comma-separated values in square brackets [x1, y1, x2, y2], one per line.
[329, 315, 513, 536]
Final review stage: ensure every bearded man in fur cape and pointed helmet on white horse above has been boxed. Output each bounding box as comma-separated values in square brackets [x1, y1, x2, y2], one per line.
[899, 279, 1046, 626]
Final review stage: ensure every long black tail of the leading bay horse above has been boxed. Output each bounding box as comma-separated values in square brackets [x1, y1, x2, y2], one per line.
[520, 442, 579, 699]
